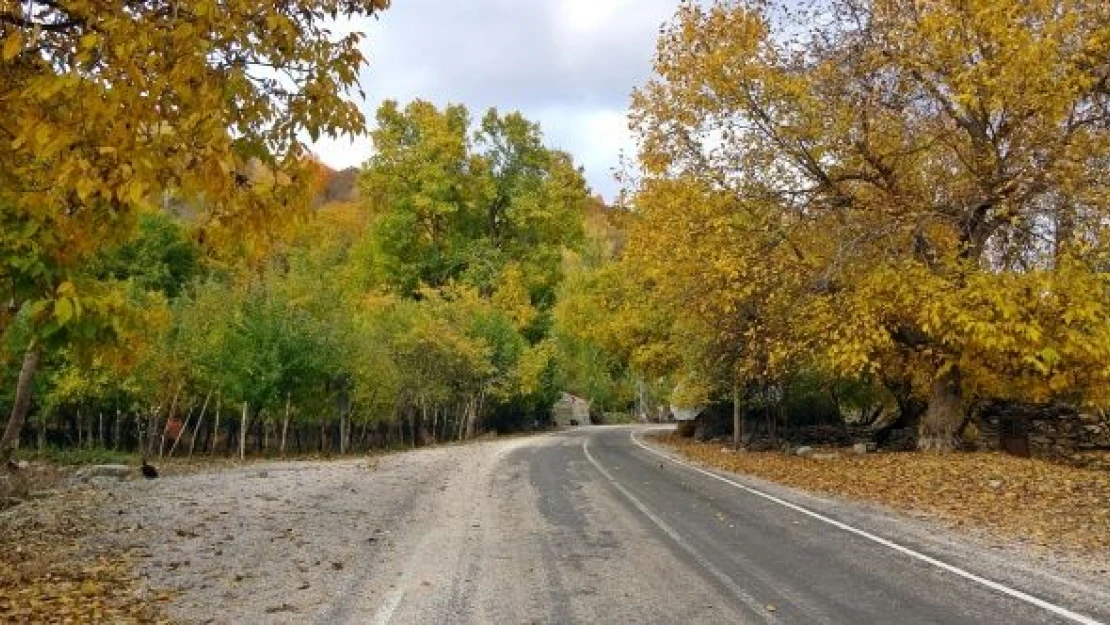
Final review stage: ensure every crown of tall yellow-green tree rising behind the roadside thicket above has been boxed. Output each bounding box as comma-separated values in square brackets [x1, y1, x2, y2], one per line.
[362, 101, 588, 308]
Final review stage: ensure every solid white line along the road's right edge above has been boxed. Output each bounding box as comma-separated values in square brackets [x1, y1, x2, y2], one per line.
[630, 432, 1104, 625]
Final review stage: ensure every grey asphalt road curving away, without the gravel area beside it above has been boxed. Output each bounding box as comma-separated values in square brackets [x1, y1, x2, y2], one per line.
[357, 427, 1107, 624]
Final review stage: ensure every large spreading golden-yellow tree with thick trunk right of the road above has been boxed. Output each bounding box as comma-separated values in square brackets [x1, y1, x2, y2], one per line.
[633, 0, 1110, 450]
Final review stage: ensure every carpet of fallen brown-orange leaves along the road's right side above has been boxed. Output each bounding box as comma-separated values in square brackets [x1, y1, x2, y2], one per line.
[658, 436, 1110, 557]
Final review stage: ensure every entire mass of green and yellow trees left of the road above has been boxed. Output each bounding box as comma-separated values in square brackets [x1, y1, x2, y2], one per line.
[0, 2, 634, 475]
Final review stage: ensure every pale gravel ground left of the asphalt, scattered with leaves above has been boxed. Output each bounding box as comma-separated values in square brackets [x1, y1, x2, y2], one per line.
[84, 441, 535, 623]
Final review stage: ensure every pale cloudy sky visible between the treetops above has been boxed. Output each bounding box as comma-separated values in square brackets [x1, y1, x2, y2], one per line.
[314, 0, 678, 199]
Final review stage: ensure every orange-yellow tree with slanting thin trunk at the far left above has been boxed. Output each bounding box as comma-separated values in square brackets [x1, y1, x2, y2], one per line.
[0, 0, 387, 454]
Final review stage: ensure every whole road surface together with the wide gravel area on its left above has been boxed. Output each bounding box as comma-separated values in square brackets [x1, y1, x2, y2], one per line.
[102, 427, 1110, 625]
